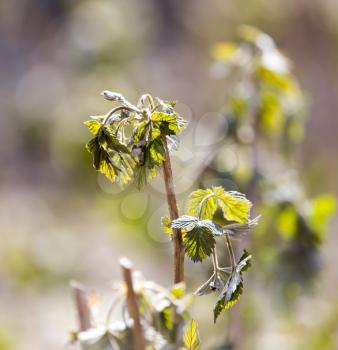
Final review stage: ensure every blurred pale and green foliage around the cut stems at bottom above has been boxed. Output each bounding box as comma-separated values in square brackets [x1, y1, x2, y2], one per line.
[73, 272, 195, 350]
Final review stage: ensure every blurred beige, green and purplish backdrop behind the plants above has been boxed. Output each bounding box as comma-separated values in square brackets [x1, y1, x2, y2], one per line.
[0, 0, 338, 350]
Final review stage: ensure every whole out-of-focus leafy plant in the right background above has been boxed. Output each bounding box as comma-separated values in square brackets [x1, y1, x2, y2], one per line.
[209, 26, 336, 297]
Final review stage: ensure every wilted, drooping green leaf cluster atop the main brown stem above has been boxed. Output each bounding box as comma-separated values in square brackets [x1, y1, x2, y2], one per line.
[85, 91, 186, 188]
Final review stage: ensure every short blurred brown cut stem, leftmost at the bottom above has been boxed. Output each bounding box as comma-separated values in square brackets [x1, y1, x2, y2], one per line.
[70, 281, 91, 332]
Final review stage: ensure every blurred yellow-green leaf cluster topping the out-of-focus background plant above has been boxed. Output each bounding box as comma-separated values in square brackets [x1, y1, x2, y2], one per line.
[212, 26, 305, 145]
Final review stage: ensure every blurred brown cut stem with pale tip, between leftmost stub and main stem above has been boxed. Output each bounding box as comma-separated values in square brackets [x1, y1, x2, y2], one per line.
[120, 258, 146, 350]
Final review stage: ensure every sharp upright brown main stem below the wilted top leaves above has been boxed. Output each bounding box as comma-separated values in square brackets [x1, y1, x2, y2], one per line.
[163, 137, 184, 283]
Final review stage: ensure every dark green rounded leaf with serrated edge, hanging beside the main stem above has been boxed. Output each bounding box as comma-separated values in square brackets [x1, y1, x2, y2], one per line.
[183, 225, 216, 262]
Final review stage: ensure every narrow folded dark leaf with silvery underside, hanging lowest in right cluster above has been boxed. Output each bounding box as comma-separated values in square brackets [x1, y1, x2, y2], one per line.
[214, 251, 251, 322]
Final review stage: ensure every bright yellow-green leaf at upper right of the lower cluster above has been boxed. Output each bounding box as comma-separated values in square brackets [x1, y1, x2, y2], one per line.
[213, 186, 252, 223]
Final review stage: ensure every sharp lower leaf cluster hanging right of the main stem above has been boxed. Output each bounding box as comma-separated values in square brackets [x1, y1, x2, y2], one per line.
[169, 187, 259, 321]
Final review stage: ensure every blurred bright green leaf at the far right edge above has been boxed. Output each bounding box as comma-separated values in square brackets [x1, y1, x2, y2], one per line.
[309, 194, 337, 241]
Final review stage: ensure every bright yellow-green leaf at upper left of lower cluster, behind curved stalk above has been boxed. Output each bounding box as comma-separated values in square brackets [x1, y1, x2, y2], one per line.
[187, 188, 217, 219]
